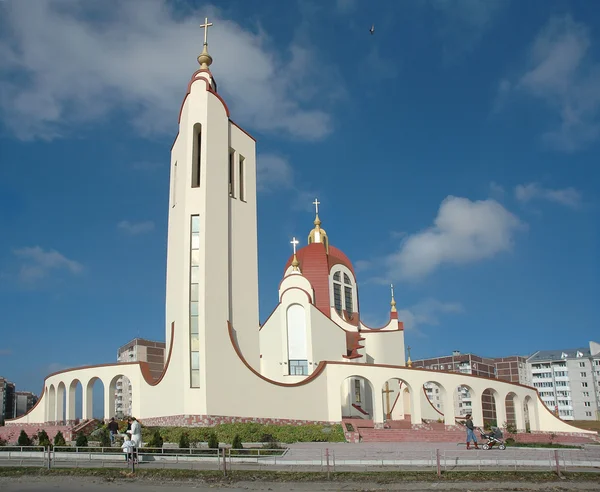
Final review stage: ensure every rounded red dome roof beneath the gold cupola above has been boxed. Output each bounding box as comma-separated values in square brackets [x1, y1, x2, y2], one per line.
[284, 243, 356, 317]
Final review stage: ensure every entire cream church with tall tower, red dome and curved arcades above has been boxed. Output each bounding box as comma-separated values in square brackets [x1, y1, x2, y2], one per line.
[7, 23, 586, 440]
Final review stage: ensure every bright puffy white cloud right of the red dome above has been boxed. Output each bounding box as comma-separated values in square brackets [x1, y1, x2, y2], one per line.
[386, 196, 525, 279]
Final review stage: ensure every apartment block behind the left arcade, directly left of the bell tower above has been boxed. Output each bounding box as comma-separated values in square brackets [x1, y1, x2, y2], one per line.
[115, 338, 165, 418]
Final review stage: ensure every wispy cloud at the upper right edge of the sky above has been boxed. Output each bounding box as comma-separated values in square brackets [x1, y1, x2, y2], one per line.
[503, 16, 600, 151]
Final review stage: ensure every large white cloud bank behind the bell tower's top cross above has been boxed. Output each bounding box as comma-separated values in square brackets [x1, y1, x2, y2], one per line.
[0, 0, 339, 140]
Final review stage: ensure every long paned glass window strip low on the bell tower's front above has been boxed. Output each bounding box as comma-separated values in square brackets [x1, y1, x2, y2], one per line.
[190, 215, 200, 388]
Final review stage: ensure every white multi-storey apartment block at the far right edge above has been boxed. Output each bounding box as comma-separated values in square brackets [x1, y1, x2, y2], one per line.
[527, 342, 600, 420]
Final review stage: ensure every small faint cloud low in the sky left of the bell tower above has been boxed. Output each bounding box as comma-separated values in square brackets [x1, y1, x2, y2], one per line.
[14, 246, 83, 284]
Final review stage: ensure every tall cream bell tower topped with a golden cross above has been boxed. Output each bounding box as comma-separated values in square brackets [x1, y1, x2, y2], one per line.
[166, 19, 259, 415]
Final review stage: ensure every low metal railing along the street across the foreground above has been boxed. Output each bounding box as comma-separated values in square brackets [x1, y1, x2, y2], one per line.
[0, 446, 600, 473]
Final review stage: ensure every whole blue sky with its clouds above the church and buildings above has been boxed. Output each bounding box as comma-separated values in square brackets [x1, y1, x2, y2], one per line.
[0, 0, 600, 400]
